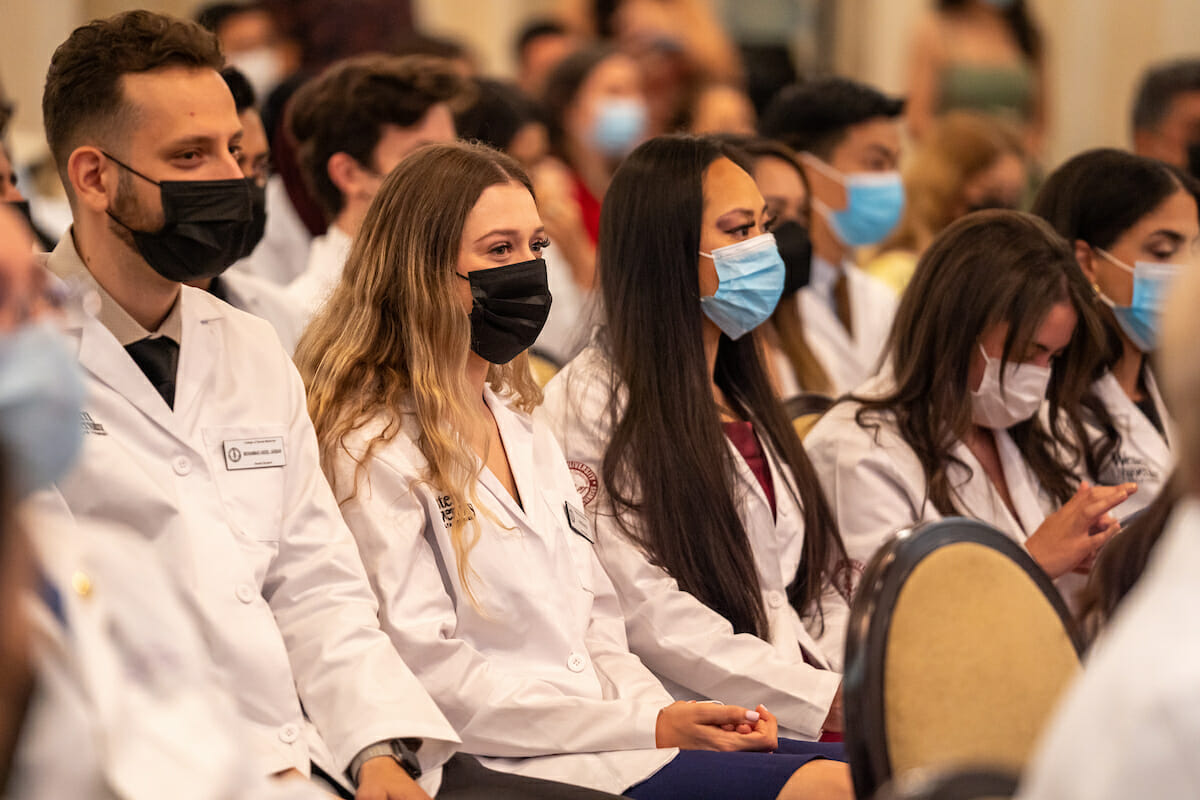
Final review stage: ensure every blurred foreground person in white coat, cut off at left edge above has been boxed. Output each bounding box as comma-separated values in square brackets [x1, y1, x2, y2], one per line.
[0, 203, 328, 800]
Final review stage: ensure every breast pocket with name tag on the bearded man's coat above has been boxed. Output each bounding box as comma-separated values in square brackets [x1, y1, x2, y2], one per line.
[204, 425, 288, 542]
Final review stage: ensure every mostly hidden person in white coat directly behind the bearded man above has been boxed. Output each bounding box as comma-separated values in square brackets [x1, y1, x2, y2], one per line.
[188, 67, 301, 353]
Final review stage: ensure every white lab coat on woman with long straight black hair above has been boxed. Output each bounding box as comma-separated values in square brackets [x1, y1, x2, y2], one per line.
[538, 347, 850, 740]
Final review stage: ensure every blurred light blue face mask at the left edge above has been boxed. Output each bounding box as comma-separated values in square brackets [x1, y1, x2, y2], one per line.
[0, 323, 84, 498]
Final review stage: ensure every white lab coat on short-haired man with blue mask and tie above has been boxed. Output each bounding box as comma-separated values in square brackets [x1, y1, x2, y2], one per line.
[796, 258, 898, 396]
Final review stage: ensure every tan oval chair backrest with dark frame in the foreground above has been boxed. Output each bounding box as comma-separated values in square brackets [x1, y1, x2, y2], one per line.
[845, 520, 1082, 798]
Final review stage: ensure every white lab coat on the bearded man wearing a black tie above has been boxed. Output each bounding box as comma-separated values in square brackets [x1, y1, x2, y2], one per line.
[49, 236, 456, 783]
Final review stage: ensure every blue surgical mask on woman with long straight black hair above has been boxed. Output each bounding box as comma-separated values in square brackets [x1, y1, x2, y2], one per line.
[700, 234, 786, 339]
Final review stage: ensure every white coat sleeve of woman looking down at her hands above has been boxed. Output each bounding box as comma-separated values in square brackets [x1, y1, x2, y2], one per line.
[804, 404, 940, 579]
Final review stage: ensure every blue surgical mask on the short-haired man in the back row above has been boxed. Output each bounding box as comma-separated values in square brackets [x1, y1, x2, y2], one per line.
[806, 156, 905, 247]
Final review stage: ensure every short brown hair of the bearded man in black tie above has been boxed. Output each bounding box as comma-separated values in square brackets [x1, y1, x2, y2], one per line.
[42, 11, 224, 176]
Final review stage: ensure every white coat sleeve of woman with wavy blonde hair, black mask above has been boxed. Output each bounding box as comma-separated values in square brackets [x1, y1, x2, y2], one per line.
[340, 456, 671, 757]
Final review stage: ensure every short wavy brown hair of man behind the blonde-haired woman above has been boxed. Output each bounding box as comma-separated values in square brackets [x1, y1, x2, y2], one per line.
[288, 55, 467, 218]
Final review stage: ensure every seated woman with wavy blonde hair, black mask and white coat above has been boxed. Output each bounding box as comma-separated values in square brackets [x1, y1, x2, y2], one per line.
[300, 145, 850, 799]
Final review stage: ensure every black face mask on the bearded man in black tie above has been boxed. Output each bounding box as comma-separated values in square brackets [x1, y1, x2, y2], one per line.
[104, 152, 258, 283]
